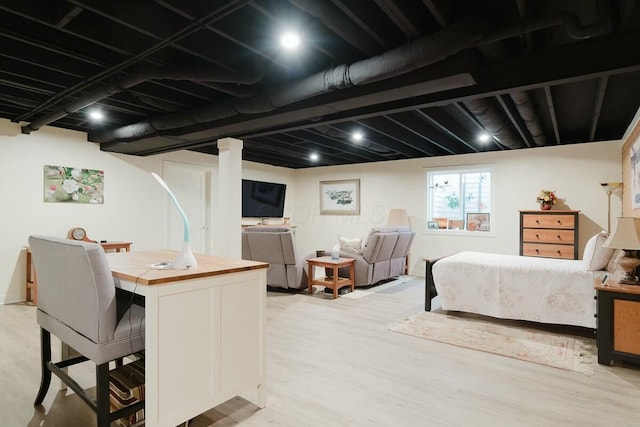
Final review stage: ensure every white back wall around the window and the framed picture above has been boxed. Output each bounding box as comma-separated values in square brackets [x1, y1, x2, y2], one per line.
[292, 141, 622, 275]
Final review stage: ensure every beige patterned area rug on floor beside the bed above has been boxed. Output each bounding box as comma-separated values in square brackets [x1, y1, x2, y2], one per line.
[389, 311, 596, 375]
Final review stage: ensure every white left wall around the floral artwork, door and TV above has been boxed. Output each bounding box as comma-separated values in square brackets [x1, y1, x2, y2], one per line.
[0, 119, 295, 303]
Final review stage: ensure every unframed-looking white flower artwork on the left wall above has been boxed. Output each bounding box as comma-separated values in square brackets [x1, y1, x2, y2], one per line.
[44, 165, 104, 204]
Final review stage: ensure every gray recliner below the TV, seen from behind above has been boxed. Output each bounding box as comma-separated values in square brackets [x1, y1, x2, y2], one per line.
[242, 226, 316, 289]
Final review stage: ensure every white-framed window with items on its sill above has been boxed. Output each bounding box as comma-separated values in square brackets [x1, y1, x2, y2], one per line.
[425, 166, 491, 232]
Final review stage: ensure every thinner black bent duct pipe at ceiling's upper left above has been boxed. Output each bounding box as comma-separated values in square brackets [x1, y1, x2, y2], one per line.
[22, 67, 262, 134]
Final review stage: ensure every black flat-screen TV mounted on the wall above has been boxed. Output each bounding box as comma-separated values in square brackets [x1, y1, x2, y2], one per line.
[242, 179, 287, 218]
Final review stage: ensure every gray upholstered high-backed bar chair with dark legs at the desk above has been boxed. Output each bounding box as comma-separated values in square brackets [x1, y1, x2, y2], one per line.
[29, 236, 144, 427]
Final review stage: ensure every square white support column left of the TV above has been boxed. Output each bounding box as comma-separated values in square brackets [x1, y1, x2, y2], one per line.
[213, 138, 242, 258]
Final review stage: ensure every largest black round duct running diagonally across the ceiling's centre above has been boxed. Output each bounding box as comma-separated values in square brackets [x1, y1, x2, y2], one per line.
[90, 17, 487, 143]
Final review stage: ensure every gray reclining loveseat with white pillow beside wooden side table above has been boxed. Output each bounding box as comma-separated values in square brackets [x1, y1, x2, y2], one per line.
[330, 227, 416, 287]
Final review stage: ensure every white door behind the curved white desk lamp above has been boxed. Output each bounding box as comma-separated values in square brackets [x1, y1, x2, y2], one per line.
[163, 162, 213, 254]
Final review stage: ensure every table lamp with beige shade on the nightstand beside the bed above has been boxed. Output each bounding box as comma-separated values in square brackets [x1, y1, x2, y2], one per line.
[602, 217, 640, 285]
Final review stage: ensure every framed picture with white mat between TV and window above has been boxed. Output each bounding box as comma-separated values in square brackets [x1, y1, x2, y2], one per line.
[320, 179, 360, 215]
